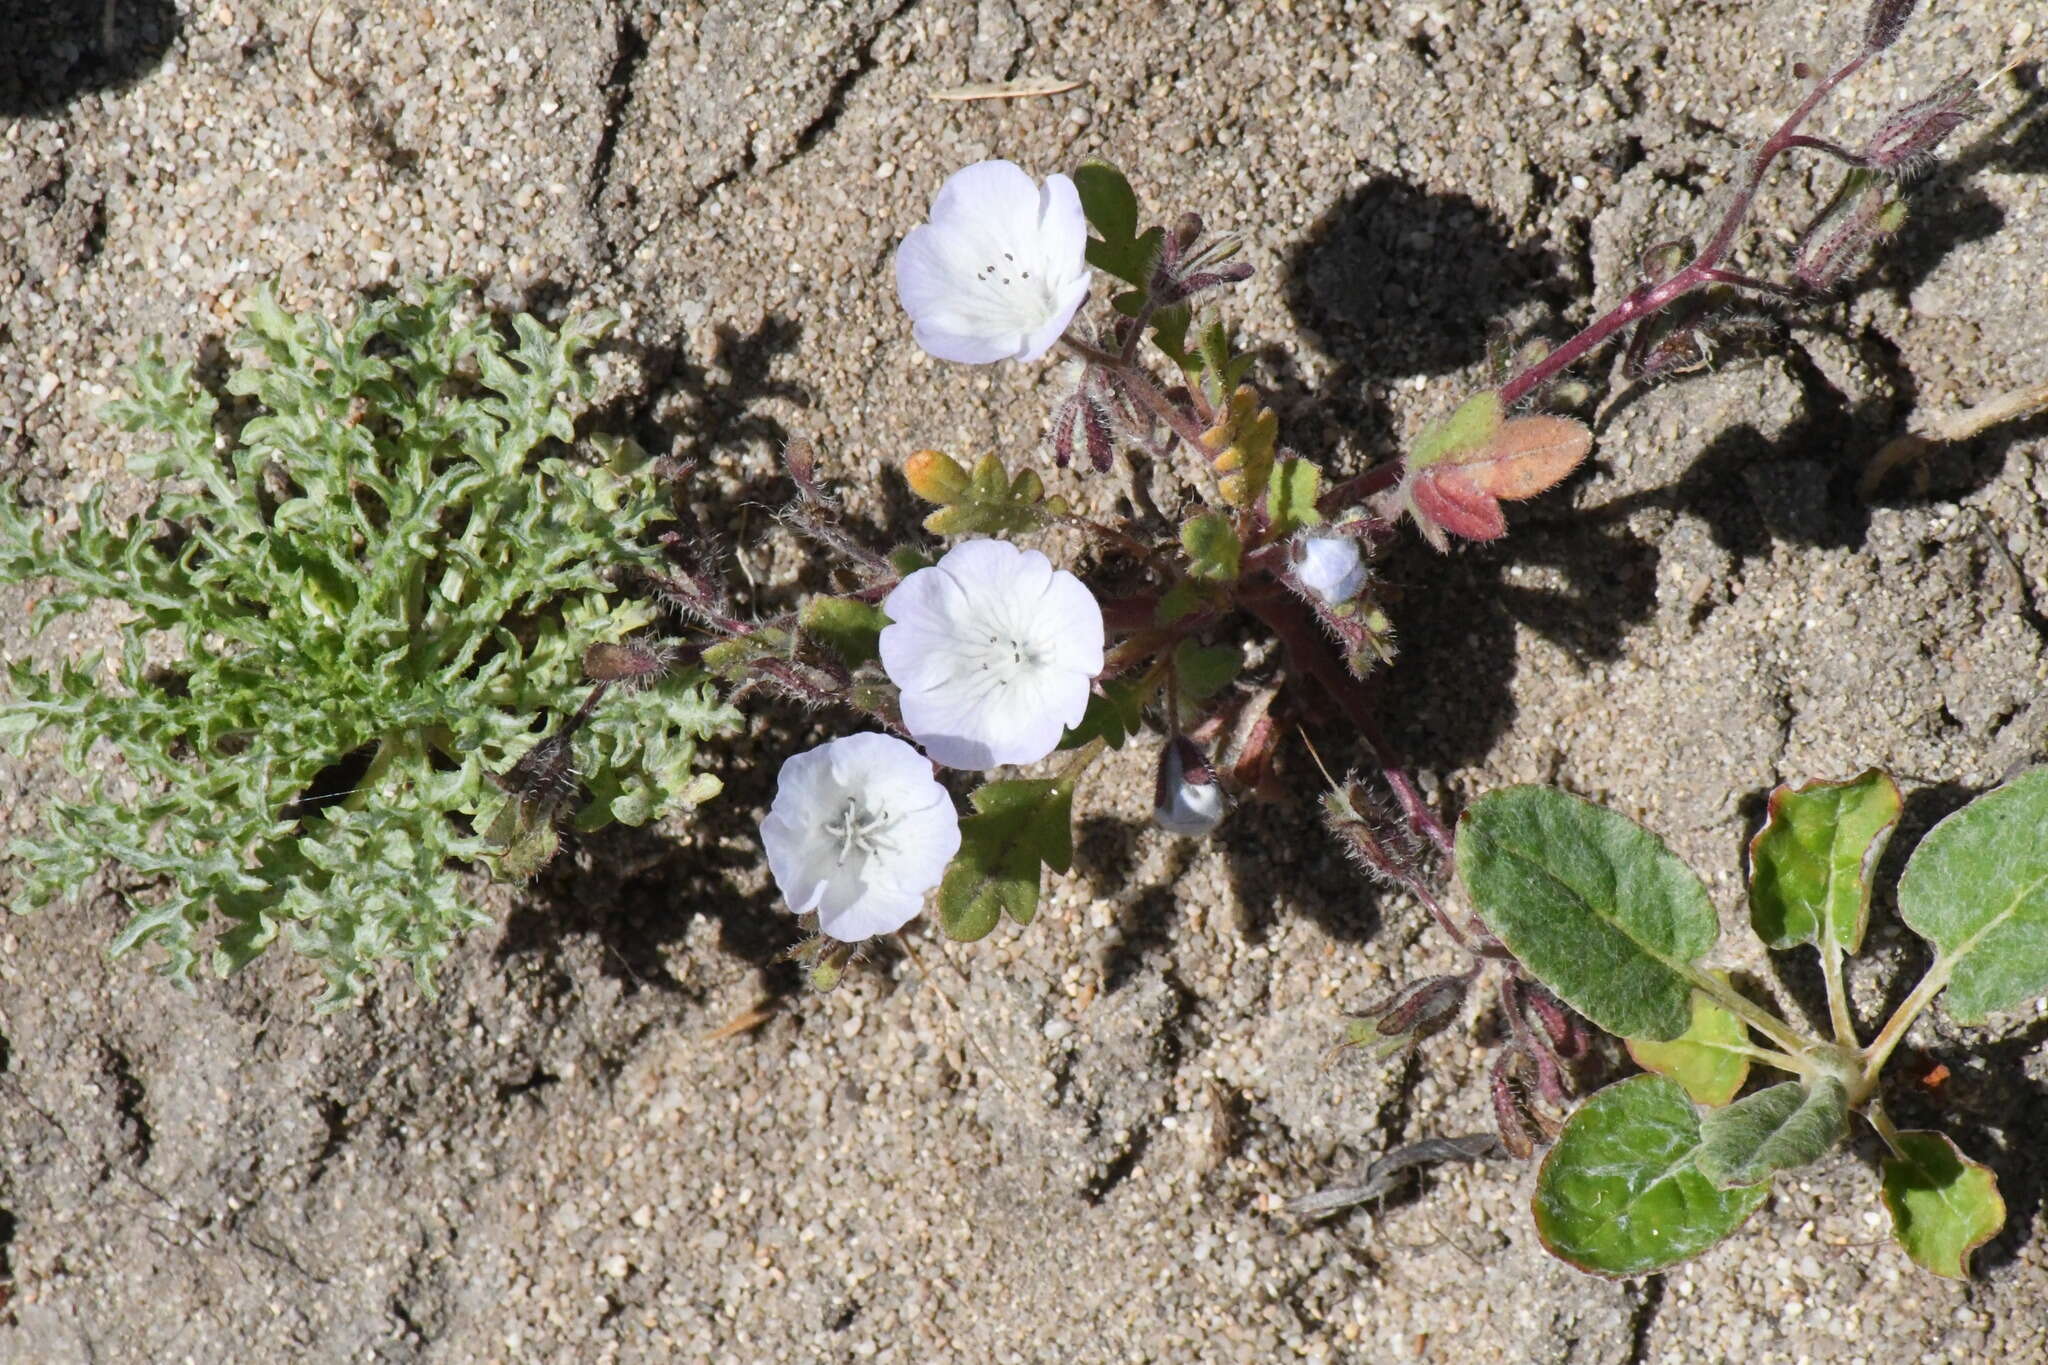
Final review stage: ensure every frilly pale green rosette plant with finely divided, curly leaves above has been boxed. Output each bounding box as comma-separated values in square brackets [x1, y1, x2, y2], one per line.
[0, 282, 733, 1009]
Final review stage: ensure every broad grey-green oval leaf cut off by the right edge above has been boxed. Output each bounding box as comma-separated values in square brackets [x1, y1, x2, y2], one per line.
[1898, 767, 2048, 1023]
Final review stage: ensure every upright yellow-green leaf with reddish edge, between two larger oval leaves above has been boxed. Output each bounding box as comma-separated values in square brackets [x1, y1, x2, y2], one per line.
[1749, 767, 1898, 954]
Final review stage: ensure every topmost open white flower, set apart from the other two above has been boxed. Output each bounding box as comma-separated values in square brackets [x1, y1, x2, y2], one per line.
[897, 162, 1087, 364]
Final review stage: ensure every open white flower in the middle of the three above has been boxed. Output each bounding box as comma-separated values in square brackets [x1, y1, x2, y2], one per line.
[881, 540, 1102, 772]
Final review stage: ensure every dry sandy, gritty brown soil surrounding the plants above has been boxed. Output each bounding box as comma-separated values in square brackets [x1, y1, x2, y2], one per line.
[0, 0, 2048, 1363]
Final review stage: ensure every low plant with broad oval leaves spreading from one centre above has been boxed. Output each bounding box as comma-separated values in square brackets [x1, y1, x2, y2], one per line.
[1456, 767, 2048, 1279]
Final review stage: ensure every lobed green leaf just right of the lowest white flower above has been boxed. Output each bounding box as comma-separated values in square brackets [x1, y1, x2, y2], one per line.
[938, 780, 1073, 939]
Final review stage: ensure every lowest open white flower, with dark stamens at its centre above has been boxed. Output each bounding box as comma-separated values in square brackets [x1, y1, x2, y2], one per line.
[762, 735, 961, 943]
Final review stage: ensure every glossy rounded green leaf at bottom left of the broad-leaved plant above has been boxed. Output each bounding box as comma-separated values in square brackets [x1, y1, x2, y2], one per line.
[1534, 1076, 1769, 1275]
